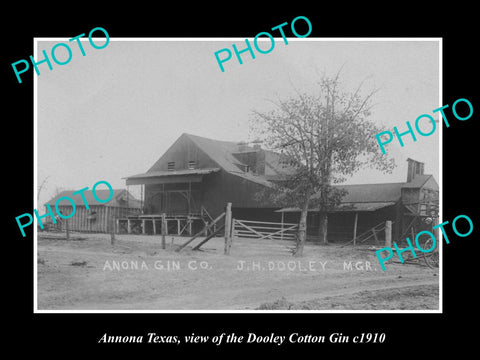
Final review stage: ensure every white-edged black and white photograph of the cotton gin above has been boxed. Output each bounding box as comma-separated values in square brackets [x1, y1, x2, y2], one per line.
[35, 38, 443, 312]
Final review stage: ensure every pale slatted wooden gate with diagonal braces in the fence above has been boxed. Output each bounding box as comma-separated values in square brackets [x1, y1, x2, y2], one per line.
[232, 219, 298, 240]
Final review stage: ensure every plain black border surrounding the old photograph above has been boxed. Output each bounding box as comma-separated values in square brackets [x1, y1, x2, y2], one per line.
[1, 2, 480, 358]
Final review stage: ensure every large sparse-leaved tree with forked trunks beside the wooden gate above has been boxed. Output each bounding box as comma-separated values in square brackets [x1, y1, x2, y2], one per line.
[252, 72, 395, 256]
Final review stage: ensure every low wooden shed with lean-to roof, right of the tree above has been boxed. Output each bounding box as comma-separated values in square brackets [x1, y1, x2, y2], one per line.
[277, 159, 439, 243]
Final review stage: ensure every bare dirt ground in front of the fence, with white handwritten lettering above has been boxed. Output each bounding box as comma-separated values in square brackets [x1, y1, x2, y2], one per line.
[37, 233, 439, 311]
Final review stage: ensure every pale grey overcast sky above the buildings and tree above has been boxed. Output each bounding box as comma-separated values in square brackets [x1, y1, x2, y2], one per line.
[33, 38, 441, 208]
